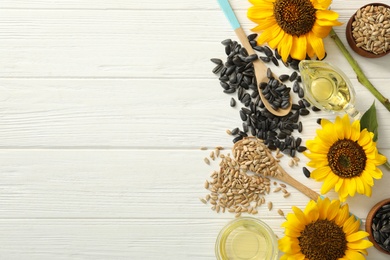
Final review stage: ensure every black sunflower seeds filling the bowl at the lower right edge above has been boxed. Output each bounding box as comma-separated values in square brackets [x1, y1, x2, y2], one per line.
[371, 204, 390, 252]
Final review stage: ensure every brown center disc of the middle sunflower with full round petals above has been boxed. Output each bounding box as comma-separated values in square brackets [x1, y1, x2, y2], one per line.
[328, 139, 367, 178]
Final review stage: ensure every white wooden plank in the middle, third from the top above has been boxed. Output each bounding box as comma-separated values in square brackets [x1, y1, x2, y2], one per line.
[0, 77, 390, 149]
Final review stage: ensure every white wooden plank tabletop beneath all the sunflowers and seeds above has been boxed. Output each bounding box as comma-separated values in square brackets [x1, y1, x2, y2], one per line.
[0, 0, 390, 260]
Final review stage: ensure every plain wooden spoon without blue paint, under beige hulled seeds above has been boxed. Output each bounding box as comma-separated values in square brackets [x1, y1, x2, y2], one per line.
[233, 137, 320, 201]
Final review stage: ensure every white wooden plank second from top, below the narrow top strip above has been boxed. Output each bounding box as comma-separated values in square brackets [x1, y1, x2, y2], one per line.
[0, 10, 388, 79]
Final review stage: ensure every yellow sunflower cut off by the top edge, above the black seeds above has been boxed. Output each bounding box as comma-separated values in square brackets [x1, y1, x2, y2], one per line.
[247, 0, 341, 61]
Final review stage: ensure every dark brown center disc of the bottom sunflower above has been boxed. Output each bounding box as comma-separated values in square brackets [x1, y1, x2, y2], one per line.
[298, 219, 347, 260]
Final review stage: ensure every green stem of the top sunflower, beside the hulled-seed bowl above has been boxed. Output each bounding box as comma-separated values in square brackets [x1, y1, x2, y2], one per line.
[329, 29, 390, 111]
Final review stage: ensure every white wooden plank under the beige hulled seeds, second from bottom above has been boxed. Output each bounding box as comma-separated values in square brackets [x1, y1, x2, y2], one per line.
[0, 149, 390, 219]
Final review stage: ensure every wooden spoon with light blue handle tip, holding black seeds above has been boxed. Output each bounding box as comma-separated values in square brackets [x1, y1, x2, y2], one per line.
[218, 0, 292, 116]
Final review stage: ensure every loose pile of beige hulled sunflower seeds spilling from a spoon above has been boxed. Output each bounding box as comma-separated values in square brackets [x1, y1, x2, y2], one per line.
[200, 140, 290, 217]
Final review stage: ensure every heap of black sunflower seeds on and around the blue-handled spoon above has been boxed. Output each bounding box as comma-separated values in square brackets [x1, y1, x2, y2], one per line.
[211, 34, 319, 157]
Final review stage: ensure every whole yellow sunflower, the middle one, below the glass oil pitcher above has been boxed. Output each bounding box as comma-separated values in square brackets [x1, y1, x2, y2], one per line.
[304, 114, 386, 201]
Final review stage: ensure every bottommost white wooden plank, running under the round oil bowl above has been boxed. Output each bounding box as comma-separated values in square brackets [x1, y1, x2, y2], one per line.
[0, 218, 387, 260]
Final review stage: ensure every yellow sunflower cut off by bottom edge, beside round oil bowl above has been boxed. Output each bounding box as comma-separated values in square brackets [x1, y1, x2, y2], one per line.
[278, 198, 372, 260]
